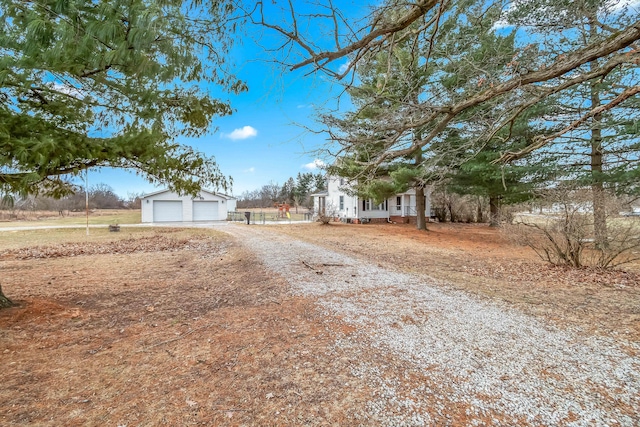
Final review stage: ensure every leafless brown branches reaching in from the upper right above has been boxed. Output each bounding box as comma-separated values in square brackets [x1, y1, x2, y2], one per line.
[245, 0, 640, 168]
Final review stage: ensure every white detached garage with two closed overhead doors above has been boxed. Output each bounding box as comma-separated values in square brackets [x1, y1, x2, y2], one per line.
[140, 190, 236, 222]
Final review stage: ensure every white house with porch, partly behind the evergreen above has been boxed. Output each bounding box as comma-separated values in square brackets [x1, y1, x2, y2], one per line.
[312, 177, 431, 223]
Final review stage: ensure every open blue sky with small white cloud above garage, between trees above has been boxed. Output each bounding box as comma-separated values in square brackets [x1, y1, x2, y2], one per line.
[89, 2, 365, 197]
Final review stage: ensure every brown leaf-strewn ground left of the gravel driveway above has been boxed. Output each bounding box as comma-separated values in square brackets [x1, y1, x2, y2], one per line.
[0, 230, 367, 426]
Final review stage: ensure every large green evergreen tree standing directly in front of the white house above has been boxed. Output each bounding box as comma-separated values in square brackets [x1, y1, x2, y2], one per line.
[325, 1, 514, 229]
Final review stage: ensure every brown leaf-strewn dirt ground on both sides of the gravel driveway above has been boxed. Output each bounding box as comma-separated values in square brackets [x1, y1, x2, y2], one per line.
[0, 224, 640, 426]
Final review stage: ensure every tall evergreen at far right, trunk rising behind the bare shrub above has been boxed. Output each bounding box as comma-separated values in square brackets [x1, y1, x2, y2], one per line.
[507, 0, 640, 248]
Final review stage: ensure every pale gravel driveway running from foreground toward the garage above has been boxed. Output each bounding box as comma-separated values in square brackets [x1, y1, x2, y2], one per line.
[222, 225, 640, 426]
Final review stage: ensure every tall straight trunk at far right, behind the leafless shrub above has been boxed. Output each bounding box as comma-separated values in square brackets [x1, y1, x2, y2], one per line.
[589, 50, 609, 249]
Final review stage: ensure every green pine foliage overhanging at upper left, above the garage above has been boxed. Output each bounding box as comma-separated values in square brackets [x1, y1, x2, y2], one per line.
[0, 0, 245, 196]
